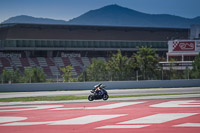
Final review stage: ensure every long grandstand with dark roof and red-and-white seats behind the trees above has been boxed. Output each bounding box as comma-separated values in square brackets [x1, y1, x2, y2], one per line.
[0, 24, 189, 78]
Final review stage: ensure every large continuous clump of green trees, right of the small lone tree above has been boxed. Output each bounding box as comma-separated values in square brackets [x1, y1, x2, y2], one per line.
[68, 47, 200, 81]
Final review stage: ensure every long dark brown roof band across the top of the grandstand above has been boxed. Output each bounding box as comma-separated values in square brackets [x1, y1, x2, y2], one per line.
[0, 23, 189, 41]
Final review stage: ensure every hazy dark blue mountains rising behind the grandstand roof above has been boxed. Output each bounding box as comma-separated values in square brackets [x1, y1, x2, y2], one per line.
[2, 5, 200, 28]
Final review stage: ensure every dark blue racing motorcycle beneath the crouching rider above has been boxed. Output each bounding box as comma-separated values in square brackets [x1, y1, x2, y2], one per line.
[88, 84, 109, 101]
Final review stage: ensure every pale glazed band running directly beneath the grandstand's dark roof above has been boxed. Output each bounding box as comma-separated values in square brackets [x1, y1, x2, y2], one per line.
[0, 40, 168, 49]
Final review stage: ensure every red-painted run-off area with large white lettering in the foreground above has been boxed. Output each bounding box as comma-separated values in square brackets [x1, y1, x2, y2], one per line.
[0, 98, 200, 133]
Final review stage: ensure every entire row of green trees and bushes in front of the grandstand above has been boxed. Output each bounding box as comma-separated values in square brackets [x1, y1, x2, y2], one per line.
[0, 47, 200, 83]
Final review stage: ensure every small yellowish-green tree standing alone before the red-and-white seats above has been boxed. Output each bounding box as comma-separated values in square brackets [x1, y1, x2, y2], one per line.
[60, 65, 72, 82]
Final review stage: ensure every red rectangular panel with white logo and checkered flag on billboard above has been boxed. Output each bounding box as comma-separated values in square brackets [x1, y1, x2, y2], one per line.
[173, 41, 195, 51]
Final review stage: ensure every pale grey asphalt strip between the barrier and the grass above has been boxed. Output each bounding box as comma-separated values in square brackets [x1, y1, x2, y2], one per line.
[0, 87, 200, 98]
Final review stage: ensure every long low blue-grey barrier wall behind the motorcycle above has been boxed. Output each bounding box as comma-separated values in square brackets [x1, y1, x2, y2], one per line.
[0, 79, 200, 92]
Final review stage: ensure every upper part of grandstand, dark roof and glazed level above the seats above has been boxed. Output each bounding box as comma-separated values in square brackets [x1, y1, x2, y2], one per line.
[0, 24, 189, 57]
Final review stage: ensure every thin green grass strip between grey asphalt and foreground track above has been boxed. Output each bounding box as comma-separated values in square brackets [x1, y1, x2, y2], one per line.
[0, 93, 200, 102]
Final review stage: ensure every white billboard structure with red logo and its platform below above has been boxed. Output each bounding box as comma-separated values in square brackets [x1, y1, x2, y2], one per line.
[160, 40, 200, 70]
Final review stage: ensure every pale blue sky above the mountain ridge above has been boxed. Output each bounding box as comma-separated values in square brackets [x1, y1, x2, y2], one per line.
[0, 0, 200, 22]
